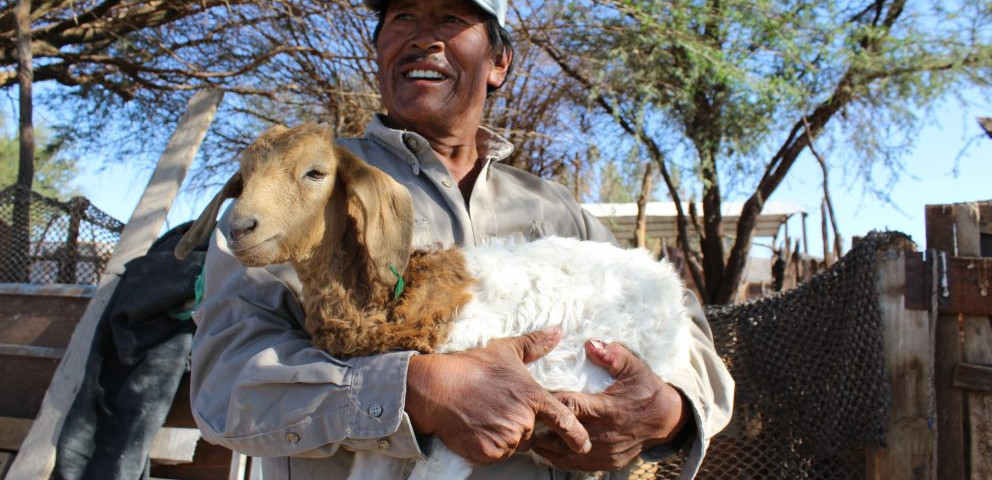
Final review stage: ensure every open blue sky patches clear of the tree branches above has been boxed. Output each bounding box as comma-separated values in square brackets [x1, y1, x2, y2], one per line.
[60, 94, 992, 256]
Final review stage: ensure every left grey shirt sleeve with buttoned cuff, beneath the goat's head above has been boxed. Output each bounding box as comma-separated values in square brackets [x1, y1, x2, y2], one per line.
[190, 212, 423, 458]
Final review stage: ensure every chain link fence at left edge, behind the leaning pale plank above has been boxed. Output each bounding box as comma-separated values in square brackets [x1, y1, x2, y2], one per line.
[0, 185, 124, 285]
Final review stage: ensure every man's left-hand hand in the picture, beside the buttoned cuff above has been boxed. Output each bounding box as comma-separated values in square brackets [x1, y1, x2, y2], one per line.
[406, 329, 591, 465]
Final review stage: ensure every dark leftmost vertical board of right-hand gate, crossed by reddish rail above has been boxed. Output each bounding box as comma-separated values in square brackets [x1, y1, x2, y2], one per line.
[926, 205, 968, 480]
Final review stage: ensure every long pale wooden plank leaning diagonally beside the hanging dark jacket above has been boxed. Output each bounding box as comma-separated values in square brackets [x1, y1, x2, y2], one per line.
[7, 90, 223, 480]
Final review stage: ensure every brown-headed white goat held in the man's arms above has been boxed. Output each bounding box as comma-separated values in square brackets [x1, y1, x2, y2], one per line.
[177, 124, 690, 480]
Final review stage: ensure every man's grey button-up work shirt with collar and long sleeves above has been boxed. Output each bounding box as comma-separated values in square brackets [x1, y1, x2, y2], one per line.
[191, 118, 733, 480]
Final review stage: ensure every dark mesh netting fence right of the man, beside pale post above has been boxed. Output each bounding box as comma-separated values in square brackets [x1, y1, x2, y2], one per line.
[631, 232, 910, 480]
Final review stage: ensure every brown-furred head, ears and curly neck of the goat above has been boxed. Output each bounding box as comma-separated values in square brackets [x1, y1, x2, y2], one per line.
[176, 124, 474, 356]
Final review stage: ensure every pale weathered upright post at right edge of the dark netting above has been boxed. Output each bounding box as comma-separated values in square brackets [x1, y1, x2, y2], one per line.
[868, 249, 937, 480]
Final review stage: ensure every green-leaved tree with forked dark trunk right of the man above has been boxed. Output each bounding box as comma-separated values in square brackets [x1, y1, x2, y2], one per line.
[527, 0, 992, 303]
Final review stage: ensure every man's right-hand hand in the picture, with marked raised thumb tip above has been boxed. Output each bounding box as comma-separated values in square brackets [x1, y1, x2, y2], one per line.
[533, 341, 692, 472]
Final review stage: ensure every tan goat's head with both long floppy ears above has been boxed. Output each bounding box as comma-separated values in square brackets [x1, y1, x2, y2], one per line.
[177, 124, 413, 283]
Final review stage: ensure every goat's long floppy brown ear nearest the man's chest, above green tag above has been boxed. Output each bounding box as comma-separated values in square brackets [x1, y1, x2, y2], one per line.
[334, 147, 413, 284]
